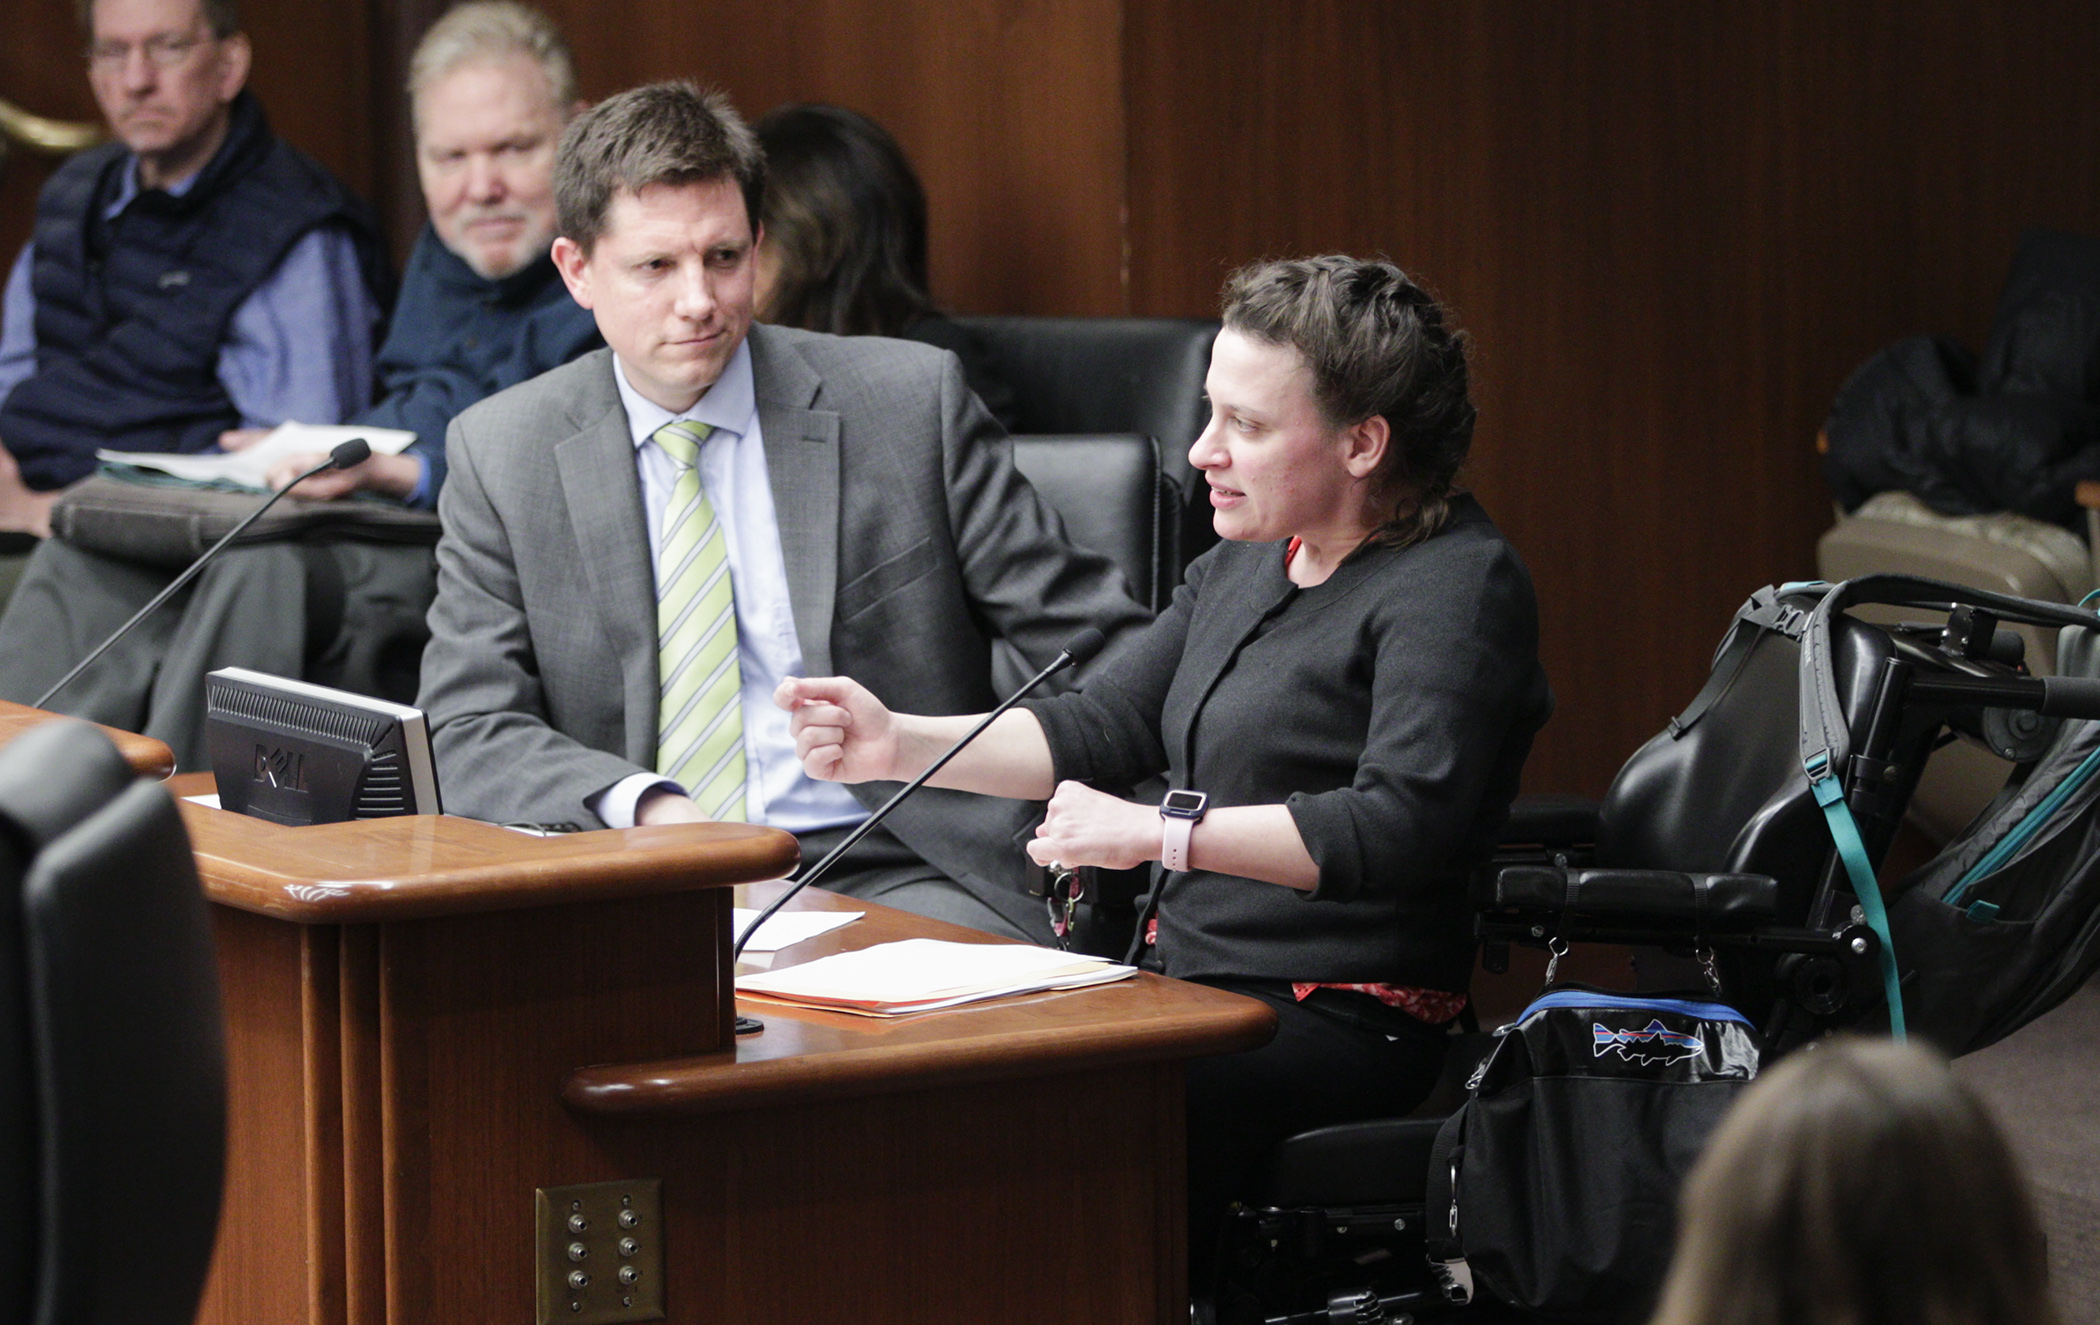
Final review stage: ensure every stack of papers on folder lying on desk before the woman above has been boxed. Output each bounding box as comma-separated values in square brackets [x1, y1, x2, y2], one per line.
[737, 939, 1136, 1016]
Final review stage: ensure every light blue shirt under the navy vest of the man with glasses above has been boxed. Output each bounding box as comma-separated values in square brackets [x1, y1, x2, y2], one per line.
[0, 162, 380, 428]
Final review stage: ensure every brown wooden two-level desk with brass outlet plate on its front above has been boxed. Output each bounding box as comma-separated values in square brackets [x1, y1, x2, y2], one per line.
[179, 779, 1271, 1325]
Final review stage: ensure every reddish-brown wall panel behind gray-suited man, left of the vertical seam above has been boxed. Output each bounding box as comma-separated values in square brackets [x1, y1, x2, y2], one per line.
[525, 0, 1124, 313]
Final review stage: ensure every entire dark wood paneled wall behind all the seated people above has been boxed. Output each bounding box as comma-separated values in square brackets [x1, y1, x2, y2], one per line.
[12, 0, 2100, 792]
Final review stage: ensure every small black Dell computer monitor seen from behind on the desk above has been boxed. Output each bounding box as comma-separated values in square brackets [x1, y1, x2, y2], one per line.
[204, 668, 439, 825]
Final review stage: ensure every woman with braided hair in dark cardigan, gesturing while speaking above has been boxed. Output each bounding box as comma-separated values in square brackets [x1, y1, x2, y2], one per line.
[775, 256, 1552, 1270]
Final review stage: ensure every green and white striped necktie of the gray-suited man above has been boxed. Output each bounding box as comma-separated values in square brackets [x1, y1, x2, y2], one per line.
[653, 420, 746, 821]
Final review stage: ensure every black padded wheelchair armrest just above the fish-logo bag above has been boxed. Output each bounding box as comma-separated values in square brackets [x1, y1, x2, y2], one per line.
[1481, 865, 1779, 932]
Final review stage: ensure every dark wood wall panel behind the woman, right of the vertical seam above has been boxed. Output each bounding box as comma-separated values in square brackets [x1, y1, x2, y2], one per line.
[1126, 0, 2100, 792]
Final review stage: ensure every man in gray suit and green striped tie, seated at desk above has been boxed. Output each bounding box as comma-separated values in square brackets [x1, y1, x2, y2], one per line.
[420, 84, 1145, 939]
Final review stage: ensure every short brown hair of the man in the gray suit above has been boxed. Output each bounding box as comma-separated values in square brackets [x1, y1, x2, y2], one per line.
[554, 80, 767, 252]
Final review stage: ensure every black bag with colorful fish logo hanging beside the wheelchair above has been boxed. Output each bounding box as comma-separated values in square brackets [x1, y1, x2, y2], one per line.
[1424, 987, 1758, 1321]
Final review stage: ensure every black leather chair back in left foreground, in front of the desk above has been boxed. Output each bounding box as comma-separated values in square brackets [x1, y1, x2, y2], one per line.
[0, 722, 227, 1325]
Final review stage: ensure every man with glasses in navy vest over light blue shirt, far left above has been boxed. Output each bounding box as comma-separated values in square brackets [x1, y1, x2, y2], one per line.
[0, 0, 384, 533]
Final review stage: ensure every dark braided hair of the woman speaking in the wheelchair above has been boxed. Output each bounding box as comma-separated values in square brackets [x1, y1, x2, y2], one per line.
[1224, 254, 1474, 546]
